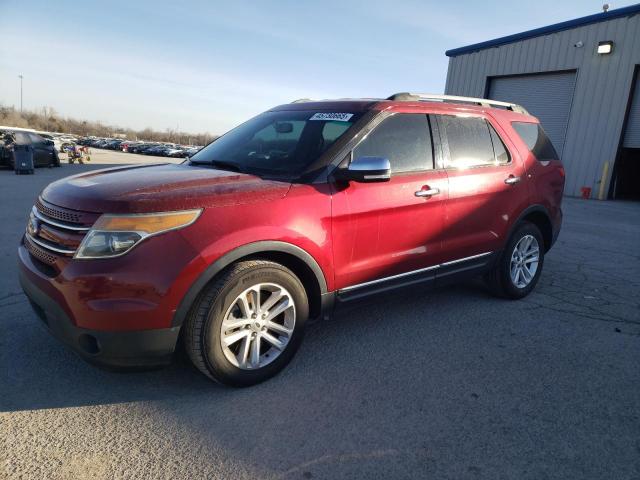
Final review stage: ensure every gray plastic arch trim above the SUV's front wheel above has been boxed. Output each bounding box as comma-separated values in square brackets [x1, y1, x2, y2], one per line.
[171, 240, 327, 327]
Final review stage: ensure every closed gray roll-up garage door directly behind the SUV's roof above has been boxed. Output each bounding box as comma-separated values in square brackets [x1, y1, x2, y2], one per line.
[489, 72, 576, 157]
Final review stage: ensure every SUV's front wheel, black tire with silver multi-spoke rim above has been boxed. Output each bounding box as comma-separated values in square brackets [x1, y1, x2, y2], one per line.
[182, 260, 309, 387]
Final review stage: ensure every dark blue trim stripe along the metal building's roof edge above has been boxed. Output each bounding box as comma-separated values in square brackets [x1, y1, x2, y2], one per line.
[445, 3, 640, 57]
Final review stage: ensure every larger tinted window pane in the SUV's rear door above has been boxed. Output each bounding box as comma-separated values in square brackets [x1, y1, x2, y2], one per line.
[440, 115, 496, 168]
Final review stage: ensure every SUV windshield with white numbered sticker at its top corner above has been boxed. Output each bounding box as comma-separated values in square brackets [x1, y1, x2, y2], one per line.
[191, 111, 360, 178]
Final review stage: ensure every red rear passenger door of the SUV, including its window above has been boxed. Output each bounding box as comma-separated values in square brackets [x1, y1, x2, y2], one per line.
[433, 113, 529, 276]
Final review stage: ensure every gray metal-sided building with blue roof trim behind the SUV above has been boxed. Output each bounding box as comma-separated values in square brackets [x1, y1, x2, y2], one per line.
[446, 4, 640, 198]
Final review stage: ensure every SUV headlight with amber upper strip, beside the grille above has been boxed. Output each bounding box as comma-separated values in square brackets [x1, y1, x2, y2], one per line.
[74, 210, 202, 259]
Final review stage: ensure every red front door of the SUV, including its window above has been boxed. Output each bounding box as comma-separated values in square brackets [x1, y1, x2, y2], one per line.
[332, 113, 447, 292]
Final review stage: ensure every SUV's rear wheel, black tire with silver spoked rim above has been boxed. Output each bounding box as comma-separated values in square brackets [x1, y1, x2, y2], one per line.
[485, 222, 544, 300]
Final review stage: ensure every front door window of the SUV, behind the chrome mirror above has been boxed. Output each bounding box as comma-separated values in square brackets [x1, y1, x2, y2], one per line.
[353, 114, 433, 172]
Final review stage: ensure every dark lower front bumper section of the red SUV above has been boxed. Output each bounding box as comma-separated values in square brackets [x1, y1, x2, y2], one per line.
[20, 255, 180, 368]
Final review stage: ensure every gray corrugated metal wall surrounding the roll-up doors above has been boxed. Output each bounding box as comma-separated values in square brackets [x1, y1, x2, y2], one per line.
[445, 15, 640, 197]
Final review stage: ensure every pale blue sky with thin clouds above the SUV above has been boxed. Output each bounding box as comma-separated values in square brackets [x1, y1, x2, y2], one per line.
[0, 0, 635, 134]
